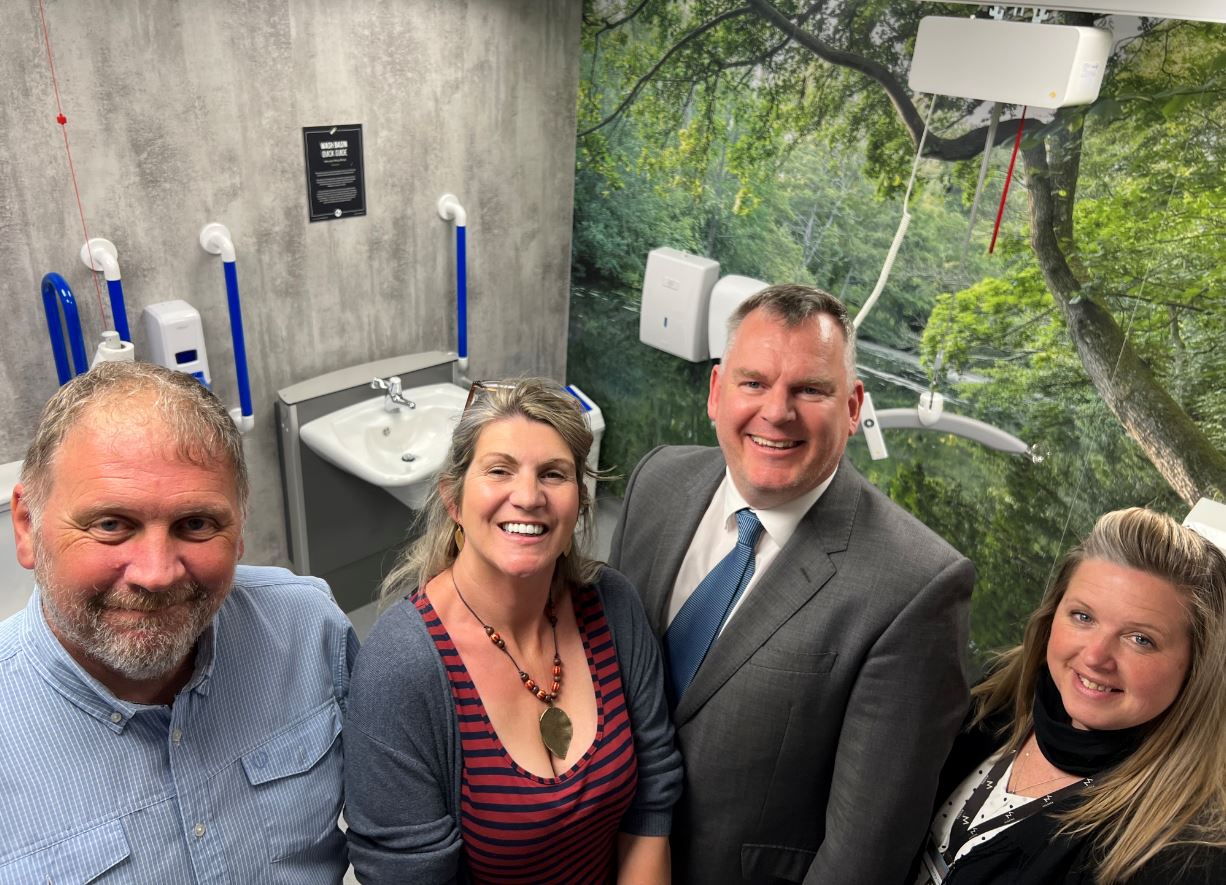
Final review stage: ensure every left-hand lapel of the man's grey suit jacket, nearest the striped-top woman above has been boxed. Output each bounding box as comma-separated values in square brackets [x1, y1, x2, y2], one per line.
[644, 449, 725, 636]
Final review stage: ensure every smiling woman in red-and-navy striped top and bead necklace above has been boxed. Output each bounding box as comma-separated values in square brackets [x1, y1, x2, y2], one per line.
[345, 380, 680, 884]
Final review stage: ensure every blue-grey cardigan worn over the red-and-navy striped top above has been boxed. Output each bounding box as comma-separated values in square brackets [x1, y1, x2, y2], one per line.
[343, 568, 682, 884]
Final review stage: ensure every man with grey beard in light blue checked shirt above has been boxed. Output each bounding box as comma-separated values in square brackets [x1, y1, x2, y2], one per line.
[0, 363, 357, 883]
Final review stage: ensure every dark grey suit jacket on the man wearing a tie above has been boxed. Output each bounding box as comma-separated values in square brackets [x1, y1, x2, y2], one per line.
[609, 446, 975, 885]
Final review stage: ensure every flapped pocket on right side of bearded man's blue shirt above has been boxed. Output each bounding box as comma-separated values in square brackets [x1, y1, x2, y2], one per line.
[243, 699, 345, 862]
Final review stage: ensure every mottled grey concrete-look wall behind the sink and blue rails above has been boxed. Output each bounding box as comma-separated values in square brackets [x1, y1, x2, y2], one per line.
[0, 0, 581, 563]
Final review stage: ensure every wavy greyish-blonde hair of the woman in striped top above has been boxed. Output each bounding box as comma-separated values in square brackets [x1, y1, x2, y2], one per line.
[380, 378, 606, 601]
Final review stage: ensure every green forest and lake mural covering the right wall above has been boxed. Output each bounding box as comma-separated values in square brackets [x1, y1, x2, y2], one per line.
[569, 0, 1226, 664]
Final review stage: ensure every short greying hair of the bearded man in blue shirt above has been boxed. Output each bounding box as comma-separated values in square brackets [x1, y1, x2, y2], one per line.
[21, 363, 250, 527]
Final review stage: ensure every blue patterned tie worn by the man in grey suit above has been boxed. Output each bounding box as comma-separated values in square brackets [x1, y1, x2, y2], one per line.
[664, 507, 763, 704]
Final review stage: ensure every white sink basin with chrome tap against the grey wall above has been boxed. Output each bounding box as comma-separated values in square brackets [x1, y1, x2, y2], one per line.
[299, 384, 468, 510]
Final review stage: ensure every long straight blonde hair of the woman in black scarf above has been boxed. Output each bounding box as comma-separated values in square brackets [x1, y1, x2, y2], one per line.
[972, 507, 1226, 885]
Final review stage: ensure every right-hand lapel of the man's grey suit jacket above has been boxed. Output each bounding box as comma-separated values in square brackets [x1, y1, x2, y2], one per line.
[673, 460, 862, 727]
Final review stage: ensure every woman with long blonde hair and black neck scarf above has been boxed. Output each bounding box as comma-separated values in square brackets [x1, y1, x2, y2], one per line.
[916, 507, 1226, 885]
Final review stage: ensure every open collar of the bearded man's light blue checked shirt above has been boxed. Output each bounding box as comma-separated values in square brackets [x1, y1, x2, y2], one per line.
[22, 586, 221, 734]
